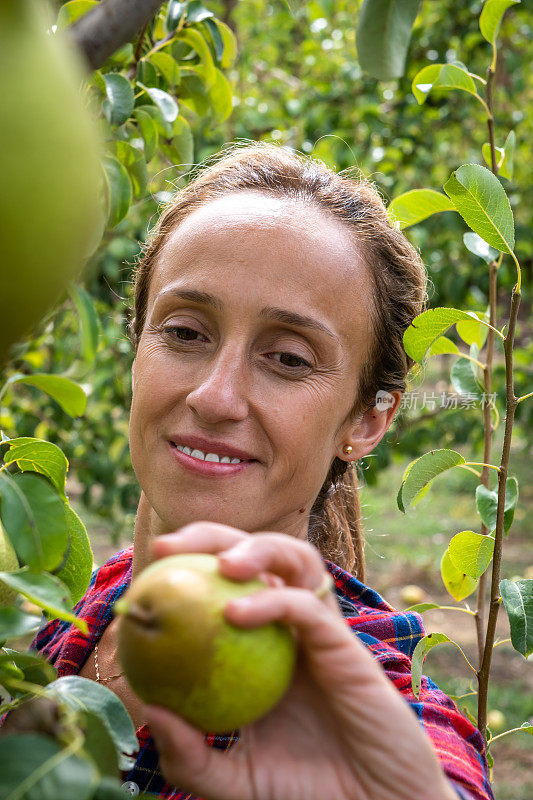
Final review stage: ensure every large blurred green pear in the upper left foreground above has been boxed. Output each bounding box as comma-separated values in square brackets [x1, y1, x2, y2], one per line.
[0, 0, 102, 365]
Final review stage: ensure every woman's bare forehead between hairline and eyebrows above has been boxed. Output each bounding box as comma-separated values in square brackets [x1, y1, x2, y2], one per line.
[148, 191, 371, 346]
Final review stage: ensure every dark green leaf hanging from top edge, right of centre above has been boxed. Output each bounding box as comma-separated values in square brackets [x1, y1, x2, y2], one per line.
[356, 0, 419, 81]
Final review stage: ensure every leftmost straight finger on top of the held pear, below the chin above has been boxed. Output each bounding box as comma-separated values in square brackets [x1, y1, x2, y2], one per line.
[152, 522, 250, 558]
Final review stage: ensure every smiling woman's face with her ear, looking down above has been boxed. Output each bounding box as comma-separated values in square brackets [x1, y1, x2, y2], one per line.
[130, 192, 387, 535]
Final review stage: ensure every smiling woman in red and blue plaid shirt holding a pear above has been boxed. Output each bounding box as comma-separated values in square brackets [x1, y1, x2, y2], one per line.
[32, 144, 493, 800]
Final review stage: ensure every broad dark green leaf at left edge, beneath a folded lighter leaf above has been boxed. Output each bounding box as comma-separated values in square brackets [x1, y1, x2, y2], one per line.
[0, 472, 68, 571]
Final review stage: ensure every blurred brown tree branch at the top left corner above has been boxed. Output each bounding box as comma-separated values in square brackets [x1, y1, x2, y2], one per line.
[70, 0, 163, 70]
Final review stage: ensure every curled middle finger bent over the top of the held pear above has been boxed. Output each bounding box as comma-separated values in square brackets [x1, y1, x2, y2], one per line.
[219, 533, 326, 591]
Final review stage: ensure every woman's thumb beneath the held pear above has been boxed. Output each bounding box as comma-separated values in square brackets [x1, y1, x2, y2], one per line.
[144, 706, 252, 800]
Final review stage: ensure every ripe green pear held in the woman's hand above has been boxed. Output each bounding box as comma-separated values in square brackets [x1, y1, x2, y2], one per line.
[115, 553, 296, 733]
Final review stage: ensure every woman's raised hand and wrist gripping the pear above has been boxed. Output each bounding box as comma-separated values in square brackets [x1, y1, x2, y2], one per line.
[145, 522, 455, 800]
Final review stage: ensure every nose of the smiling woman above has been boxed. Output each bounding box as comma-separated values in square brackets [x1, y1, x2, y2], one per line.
[185, 348, 248, 423]
